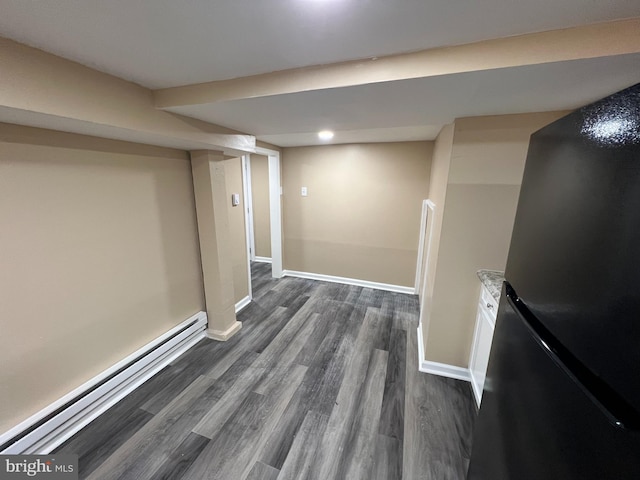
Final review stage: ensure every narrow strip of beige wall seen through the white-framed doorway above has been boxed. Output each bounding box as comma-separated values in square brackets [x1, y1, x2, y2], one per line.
[251, 154, 271, 258]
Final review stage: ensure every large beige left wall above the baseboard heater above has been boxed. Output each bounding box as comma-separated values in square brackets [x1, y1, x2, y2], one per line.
[0, 124, 204, 432]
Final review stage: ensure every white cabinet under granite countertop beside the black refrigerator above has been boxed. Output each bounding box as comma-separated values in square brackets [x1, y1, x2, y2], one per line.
[469, 285, 498, 407]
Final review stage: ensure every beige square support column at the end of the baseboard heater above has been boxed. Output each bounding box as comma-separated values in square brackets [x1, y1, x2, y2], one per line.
[191, 150, 242, 341]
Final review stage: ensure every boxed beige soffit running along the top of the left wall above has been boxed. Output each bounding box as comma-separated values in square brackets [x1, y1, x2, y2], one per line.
[0, 37, 255, 154]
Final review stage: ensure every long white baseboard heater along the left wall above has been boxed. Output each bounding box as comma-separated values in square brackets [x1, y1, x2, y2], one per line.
[0, 312, 207, 455]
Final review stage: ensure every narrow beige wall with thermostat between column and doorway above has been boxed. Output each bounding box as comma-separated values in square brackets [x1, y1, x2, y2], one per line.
[224, 158, 249, 303]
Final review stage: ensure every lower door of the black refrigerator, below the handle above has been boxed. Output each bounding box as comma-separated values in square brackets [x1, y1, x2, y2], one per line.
[467, 295, 640, 480]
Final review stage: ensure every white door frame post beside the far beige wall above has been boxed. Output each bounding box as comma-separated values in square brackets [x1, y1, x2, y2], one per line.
[254, 147, 282, 278]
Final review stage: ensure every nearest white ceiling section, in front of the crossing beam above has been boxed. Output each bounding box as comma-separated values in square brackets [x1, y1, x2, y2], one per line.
[0, 0, 640, 89]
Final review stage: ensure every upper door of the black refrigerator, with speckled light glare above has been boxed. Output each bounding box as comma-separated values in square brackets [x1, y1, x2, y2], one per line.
[505, 85, 640, 409]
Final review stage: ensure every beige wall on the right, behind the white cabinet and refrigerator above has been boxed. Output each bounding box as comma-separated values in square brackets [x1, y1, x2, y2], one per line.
[423, 112, 563, 367]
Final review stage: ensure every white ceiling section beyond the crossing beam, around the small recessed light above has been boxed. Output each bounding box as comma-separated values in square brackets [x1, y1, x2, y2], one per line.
[168, 54, 640, 147]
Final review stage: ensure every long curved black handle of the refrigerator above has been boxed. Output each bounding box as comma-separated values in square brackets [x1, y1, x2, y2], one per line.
[505, 282, 640, 431]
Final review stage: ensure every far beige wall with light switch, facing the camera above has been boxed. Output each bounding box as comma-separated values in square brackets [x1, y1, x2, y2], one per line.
[282, 142, 433, 287]
